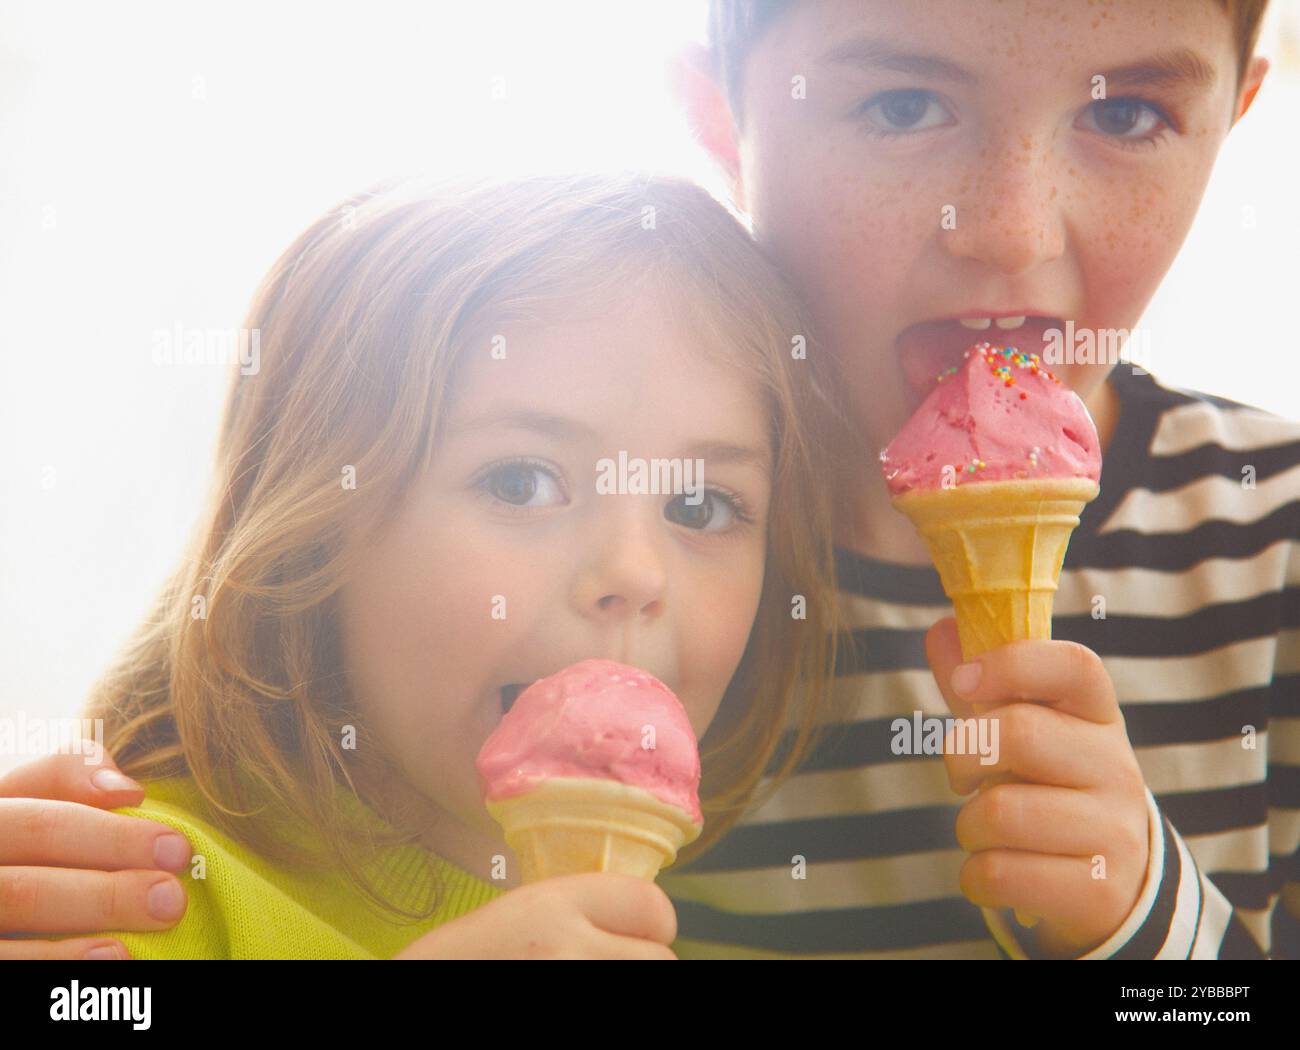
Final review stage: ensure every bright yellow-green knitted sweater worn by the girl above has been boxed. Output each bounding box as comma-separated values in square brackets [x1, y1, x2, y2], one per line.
[98, 777, 504, 959]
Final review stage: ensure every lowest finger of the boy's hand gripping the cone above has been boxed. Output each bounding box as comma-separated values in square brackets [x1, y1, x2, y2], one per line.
[958, 850, 1138, 933]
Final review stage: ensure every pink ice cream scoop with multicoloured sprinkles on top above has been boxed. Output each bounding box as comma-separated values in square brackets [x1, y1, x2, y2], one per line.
[880, 343, 1101, 496]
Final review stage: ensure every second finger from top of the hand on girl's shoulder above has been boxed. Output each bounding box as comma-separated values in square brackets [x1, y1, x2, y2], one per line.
[0, 798, 192, 872]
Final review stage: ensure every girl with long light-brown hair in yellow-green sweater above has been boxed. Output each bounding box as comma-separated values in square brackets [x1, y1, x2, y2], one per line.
[63, 175, 844, 958]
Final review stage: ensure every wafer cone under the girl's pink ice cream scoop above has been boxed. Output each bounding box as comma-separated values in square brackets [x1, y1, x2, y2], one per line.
[488, 777, 701, 882]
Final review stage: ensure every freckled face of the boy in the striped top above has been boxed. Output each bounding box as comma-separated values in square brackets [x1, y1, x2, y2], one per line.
[740, 0, 1236, 447]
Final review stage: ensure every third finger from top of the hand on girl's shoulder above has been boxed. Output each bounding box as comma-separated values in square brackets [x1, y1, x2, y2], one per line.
[0, 867, 189, 934]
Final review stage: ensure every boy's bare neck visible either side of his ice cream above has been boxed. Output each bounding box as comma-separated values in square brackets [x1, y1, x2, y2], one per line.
[835, 365, 1123, 565]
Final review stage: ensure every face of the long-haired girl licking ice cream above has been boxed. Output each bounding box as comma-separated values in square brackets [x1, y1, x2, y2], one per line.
[341, 287, 771, 865]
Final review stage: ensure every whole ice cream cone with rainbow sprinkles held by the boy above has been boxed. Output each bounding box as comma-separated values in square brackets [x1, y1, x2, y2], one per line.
[880, 333, 1101, 927]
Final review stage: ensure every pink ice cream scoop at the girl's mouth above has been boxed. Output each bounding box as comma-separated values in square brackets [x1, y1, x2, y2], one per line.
[476, 659, 703, 824]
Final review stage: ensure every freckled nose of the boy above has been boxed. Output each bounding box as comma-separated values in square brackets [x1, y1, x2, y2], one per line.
[943, 141, 1066, 277]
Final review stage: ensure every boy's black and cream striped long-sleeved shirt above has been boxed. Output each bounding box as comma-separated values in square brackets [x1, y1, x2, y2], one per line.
[659, 361, 1300, 959]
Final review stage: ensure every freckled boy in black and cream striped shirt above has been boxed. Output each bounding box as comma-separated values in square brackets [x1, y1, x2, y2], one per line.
[660, 0, 1300, 958]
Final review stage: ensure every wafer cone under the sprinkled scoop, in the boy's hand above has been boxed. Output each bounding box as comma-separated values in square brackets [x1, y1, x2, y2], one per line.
[893, 478, 1100, 660]
